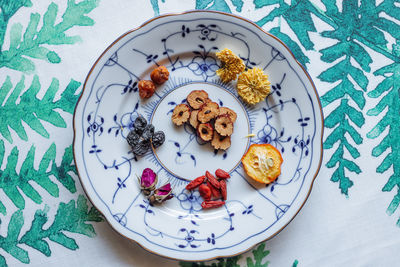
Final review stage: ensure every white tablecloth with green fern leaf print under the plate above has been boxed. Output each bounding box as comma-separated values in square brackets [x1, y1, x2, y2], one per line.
[0, 0, 400, 266]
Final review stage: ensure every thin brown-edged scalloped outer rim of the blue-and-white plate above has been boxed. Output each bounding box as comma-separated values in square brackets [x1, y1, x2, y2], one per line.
[72, 10, 325, 262]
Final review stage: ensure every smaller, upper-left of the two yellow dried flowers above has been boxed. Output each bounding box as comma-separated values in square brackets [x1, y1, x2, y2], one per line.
[216, 48, 245, 82]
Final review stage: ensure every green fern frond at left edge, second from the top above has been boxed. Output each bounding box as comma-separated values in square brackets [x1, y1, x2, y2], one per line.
[0, 76, 80, 143]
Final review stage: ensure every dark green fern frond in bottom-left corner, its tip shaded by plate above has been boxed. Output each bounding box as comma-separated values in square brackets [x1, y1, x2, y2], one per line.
[0, 195, 102, 266]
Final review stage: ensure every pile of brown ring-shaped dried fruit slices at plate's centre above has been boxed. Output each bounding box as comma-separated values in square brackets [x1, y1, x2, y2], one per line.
[171, 90, 237, 150]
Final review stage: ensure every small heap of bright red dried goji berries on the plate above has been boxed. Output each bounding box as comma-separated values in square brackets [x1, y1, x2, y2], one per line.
[186, 169, 231, 209]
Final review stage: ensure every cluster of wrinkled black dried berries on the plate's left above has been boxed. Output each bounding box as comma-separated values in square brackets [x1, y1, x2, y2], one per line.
[126, 116, 165, 156]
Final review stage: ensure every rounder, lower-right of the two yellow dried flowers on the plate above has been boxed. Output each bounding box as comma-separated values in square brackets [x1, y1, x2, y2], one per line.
[236, 68, 271, 104]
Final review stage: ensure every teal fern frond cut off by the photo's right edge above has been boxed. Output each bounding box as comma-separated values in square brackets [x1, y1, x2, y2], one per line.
[367, 41, 400, 227]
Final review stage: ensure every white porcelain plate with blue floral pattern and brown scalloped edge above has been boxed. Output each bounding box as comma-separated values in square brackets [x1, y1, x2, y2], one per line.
[74, 11, 323, 260]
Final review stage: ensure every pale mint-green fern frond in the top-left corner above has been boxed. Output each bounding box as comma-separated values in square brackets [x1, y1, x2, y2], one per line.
[0, 0, 99, 72]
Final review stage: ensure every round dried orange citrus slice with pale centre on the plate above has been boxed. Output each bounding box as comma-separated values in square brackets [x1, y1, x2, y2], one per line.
[242, 144, 283, 184]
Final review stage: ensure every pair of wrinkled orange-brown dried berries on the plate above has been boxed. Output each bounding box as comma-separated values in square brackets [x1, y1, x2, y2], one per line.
[138, 66, 169, 98]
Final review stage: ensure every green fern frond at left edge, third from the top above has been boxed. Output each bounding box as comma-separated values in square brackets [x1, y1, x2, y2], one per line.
[0, 140, 76, 215]
